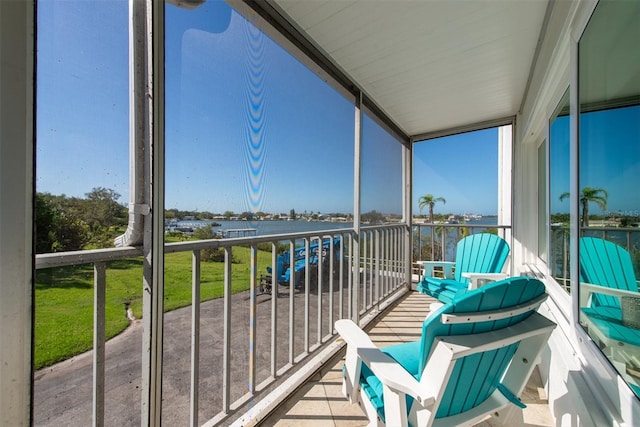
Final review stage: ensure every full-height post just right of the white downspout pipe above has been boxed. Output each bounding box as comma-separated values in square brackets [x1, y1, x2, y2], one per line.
[139, 0, 164, 426]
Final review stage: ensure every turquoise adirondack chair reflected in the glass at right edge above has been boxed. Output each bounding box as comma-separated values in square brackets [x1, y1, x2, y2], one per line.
[579, 237, 640, 352]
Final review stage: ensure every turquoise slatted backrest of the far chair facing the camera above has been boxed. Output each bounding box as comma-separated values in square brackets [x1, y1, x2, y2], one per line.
[454, 233, 509, 282]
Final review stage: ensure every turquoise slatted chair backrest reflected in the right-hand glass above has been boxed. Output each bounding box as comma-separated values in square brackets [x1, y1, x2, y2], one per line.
[580, 237, 638, 308]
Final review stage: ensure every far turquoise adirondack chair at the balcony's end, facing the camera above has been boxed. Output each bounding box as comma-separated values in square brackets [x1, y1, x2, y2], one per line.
[416, 233, 509, 302]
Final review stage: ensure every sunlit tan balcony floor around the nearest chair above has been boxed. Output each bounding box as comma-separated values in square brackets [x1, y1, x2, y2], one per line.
[262, 292, 554, 427]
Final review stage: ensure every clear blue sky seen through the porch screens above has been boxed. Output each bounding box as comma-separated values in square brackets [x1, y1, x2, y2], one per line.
[37, 0, 524, 214]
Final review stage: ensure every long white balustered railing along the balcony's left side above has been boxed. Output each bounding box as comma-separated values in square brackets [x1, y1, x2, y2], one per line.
[34, 225, 409, 425]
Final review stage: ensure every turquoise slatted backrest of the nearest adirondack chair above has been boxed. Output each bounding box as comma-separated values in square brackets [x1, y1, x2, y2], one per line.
[420, 277, 545, 418]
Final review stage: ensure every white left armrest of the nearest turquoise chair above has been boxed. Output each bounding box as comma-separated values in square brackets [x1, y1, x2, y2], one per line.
[335, 319, 435, 407]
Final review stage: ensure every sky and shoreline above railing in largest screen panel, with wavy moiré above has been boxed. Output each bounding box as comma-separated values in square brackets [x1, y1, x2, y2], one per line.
[165, 1, 354, 235]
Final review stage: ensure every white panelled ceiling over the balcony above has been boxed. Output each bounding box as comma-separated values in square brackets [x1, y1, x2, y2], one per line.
[275, 0, 547, 139]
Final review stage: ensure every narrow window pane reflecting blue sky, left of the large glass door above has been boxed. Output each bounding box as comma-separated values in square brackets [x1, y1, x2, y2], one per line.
[548, 89, 570, 292]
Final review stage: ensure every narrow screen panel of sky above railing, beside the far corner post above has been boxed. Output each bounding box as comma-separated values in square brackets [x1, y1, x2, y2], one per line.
[360, 114, 403, 225]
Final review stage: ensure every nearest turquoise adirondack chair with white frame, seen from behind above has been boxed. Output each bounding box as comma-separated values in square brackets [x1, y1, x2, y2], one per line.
[335, 277, 555, 427]
